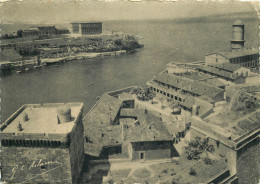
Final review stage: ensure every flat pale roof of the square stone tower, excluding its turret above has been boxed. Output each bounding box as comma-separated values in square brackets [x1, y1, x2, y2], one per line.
[2, 103, 83, 134]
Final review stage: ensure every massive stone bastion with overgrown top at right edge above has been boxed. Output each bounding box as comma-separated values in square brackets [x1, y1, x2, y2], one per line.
[191, 88, 260, 183]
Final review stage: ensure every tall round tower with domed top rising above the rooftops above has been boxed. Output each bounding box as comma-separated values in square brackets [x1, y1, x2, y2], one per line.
[230, 20, 245, 49]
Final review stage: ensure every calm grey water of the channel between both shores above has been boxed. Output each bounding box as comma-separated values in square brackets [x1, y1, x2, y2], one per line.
[0, 18, 257, 121]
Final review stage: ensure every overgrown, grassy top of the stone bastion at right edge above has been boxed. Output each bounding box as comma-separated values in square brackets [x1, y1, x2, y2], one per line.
[204, 92, 260, 140]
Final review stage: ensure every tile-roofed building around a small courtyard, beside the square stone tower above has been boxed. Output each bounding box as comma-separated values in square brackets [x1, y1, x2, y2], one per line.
[83, 94, 176, 160]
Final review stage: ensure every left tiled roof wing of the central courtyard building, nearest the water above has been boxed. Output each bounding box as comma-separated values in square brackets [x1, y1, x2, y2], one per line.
[83, 94, 122, 156]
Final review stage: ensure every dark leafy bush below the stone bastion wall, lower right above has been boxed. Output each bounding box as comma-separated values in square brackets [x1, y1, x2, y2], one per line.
[185, 137, 214, 160]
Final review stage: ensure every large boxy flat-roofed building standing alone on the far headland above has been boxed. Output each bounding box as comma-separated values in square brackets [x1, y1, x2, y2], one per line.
[71, 22, 102, 35]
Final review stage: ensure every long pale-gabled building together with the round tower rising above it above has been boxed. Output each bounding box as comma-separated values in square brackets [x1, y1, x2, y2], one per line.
[205, 20, 259, 68]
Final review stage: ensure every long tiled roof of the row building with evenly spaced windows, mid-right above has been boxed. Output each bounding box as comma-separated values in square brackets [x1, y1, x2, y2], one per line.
[154, 74, 223, 98]
